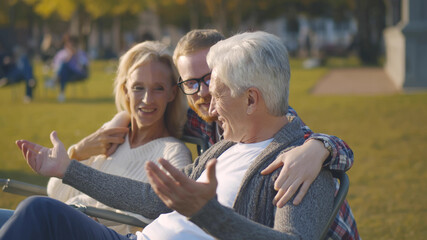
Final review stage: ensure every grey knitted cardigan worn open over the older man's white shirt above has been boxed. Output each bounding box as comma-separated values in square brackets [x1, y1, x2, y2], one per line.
[63, 118, 335, 240]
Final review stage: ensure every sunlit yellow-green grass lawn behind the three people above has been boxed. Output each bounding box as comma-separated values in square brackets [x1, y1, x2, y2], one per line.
[0, 60, 427, 239]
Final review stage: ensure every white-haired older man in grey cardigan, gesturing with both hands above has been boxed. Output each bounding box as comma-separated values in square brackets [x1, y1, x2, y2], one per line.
[4, 32, 335, 239]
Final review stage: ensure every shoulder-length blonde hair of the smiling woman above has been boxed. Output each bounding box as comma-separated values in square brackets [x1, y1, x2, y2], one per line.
[114, 41, 188, 138]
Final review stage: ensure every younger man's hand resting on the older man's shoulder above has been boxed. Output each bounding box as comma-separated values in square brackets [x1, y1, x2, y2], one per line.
[261, 140, 329, 208]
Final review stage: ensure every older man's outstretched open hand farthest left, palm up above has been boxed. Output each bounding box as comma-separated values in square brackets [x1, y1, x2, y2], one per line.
[16, 131, 71, 178]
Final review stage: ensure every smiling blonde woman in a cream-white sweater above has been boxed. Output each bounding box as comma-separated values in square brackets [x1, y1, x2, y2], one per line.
[48, 41, 191, 234]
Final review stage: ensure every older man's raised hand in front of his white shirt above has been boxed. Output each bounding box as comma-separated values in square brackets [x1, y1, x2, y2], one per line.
[146, 159, 218, 217]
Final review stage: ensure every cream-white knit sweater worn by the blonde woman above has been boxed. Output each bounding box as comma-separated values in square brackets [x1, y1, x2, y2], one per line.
[47, 136, 191, 234]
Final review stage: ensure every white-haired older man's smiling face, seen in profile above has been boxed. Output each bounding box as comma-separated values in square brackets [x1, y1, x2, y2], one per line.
[209, 69, 248, 142]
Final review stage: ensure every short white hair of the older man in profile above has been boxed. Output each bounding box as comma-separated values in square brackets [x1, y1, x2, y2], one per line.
[207, 31, 291, 116]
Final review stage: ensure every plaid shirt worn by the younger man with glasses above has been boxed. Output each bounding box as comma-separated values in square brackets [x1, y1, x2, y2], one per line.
[184, 107, 360, 240]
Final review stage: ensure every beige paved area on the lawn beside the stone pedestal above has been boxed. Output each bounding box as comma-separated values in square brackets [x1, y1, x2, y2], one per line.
[312, 68, 401, 95]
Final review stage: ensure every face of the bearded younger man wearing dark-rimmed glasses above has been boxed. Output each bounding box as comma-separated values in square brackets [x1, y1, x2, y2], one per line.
[177, 48, 216, 122]
